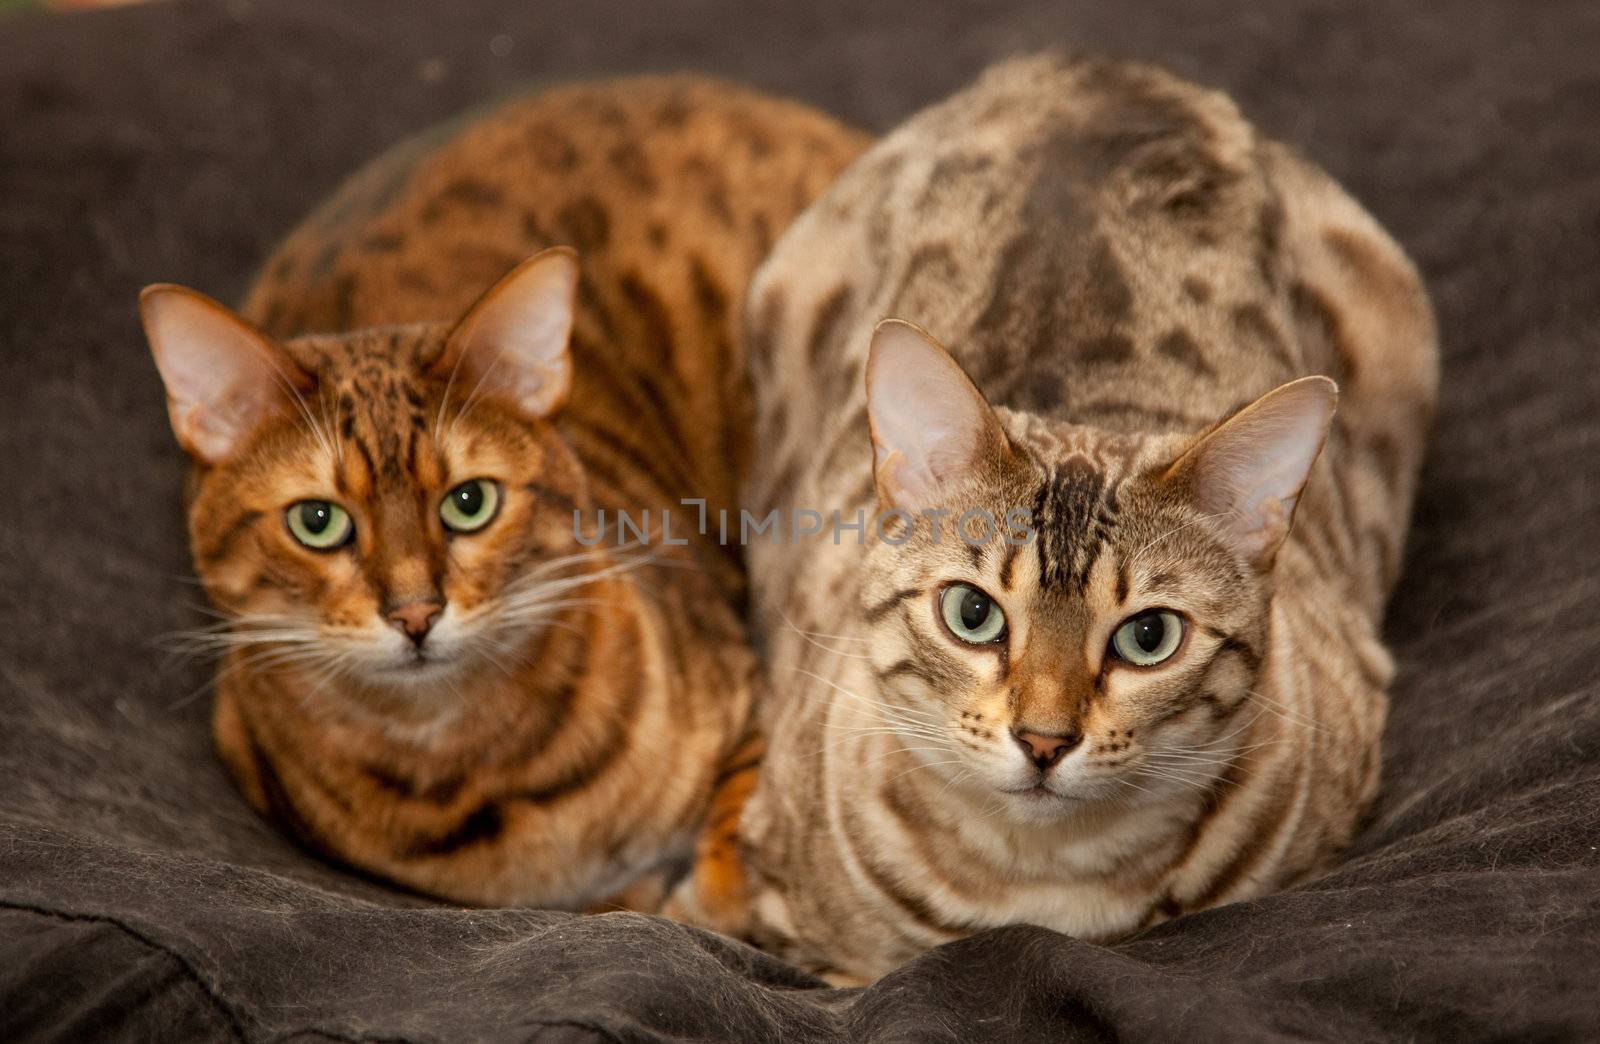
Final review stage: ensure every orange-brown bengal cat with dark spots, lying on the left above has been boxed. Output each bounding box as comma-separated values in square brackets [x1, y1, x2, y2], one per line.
[142, 77, 864, 908]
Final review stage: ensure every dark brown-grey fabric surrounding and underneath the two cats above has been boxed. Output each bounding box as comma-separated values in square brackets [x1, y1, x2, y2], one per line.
[0, 0, 1600, 1041]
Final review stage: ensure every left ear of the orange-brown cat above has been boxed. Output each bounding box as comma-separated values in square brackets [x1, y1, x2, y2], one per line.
[139, 283, 315, 464]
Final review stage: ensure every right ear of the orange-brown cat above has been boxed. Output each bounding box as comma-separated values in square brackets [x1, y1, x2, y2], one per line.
[432, 247, 578, 418]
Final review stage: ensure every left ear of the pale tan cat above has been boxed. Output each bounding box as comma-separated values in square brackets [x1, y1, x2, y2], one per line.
[867, 319, 1010, 511]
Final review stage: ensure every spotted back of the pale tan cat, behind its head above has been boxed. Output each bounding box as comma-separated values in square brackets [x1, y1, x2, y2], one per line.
[750, 54, 1437, 602]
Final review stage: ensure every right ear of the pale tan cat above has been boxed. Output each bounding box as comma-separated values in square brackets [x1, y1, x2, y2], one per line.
[1168, 376, 1339, 570]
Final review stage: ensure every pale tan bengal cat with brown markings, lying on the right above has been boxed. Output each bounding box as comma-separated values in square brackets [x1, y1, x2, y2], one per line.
[678, 56, 1437, 982]
